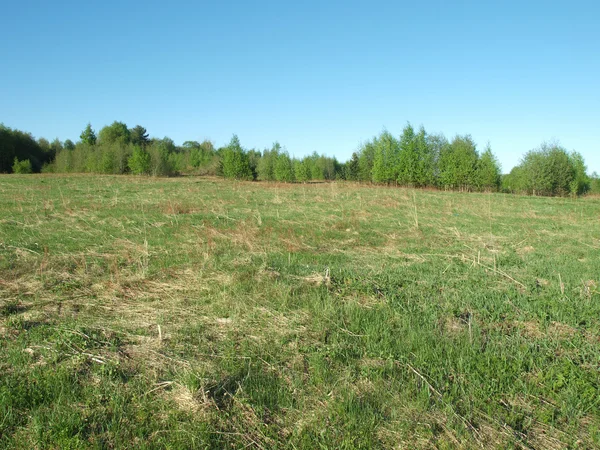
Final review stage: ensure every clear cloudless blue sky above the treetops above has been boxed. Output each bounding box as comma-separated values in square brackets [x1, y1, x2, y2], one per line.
[0, 0, 600, 172]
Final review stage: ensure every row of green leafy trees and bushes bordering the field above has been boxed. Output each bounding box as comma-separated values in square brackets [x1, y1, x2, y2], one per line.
[0, 122, 600, 196]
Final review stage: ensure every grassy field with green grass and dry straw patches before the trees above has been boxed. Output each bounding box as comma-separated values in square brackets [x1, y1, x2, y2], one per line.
[0, 175, 600, 449]
